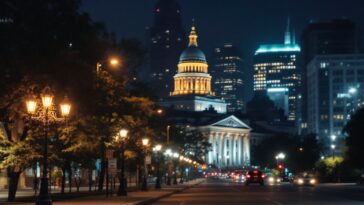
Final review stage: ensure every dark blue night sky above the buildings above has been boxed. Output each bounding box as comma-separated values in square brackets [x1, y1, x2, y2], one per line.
[82, 0, 364, 98]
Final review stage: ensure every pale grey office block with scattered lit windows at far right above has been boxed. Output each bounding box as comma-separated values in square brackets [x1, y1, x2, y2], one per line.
[307, 54, 364, 142]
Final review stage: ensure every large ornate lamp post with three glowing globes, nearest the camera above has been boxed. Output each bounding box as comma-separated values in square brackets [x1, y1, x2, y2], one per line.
[26, 87, 71, 205]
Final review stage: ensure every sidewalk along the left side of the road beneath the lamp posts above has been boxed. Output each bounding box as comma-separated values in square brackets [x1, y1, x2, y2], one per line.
[1, 179, 205, 205]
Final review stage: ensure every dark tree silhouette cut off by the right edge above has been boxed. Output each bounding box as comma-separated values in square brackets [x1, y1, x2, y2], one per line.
[344, 108, 364, 170]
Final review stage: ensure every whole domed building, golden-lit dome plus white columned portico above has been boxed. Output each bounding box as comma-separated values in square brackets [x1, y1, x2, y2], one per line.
[159, 21, 251, 169]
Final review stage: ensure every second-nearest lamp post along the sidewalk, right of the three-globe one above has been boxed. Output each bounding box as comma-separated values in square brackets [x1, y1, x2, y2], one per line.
[115, 129, 128, 196]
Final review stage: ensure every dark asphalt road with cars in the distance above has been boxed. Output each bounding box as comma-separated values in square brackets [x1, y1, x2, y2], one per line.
[153, 179, 364, 205]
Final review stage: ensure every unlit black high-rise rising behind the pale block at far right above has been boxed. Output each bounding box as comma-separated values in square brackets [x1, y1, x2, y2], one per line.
[301, 19, 359, 131]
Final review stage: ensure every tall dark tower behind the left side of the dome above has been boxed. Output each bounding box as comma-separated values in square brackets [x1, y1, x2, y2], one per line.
[149, 0, 186, 99]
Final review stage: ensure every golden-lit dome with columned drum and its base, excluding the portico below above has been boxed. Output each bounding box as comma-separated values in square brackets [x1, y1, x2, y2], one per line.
[162, 22, 227, 113]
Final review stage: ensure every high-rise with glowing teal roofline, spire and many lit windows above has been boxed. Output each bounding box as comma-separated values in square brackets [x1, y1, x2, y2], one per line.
[254, 20, 301, 122]
